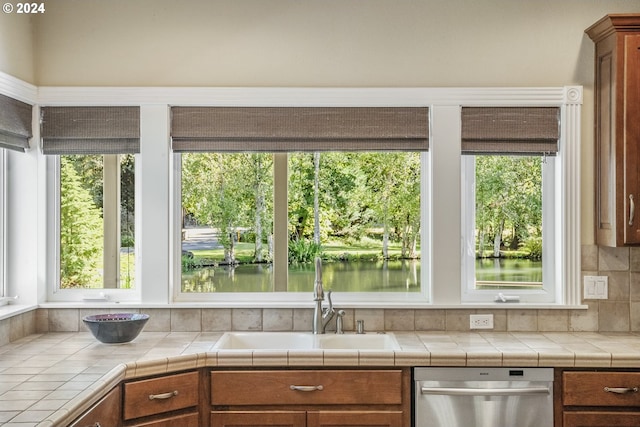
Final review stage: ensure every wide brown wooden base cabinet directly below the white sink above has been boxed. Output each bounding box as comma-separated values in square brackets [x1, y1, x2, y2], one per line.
[211, 368, 411, 427]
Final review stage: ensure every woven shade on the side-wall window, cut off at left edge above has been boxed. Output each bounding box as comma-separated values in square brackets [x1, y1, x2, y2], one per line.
[0, 95, 33, 152]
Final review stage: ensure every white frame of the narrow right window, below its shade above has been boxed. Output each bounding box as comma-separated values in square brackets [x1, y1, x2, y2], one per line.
[461, 154, 561, 303]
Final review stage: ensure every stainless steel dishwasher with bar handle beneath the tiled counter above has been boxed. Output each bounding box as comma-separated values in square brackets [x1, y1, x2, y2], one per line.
[413, 368, 553, 427]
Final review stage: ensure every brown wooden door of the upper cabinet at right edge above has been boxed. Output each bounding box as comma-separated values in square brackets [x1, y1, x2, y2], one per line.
[624, 34, 640, 244]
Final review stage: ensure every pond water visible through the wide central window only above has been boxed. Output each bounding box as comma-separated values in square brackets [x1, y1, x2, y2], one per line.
[182, 260, 420, 292]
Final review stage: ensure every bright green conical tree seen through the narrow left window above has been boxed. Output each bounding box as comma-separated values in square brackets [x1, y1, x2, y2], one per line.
[60, 156, 103, 288]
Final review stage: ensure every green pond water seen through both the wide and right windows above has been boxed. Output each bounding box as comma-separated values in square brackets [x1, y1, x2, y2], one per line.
[182, 259, 542, 292]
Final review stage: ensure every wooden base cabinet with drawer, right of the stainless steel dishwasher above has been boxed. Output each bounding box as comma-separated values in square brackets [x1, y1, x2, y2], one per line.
[557, 371, 640, 427]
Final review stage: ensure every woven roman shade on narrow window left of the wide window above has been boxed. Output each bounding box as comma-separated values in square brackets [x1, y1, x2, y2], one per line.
[41, 107, 140, 155]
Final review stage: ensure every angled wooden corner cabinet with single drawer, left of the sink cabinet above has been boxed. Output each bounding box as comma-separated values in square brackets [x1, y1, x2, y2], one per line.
[122, 371, 200, 427]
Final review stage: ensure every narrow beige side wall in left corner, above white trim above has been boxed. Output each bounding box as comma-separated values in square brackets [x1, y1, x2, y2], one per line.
[0, 11, 35, 83]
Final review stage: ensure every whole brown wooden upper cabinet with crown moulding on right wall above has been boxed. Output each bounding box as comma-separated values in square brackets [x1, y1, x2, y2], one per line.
[586, 14, 640, 246]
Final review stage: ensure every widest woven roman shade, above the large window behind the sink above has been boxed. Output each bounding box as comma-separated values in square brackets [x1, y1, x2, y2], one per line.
[171, 107, 429, 152]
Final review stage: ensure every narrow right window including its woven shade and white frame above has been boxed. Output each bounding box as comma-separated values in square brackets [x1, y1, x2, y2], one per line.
[461, 107, 560, 303]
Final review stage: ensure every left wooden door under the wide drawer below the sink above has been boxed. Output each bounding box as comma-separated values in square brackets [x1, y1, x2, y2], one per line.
[211, 411, 306, 427]
